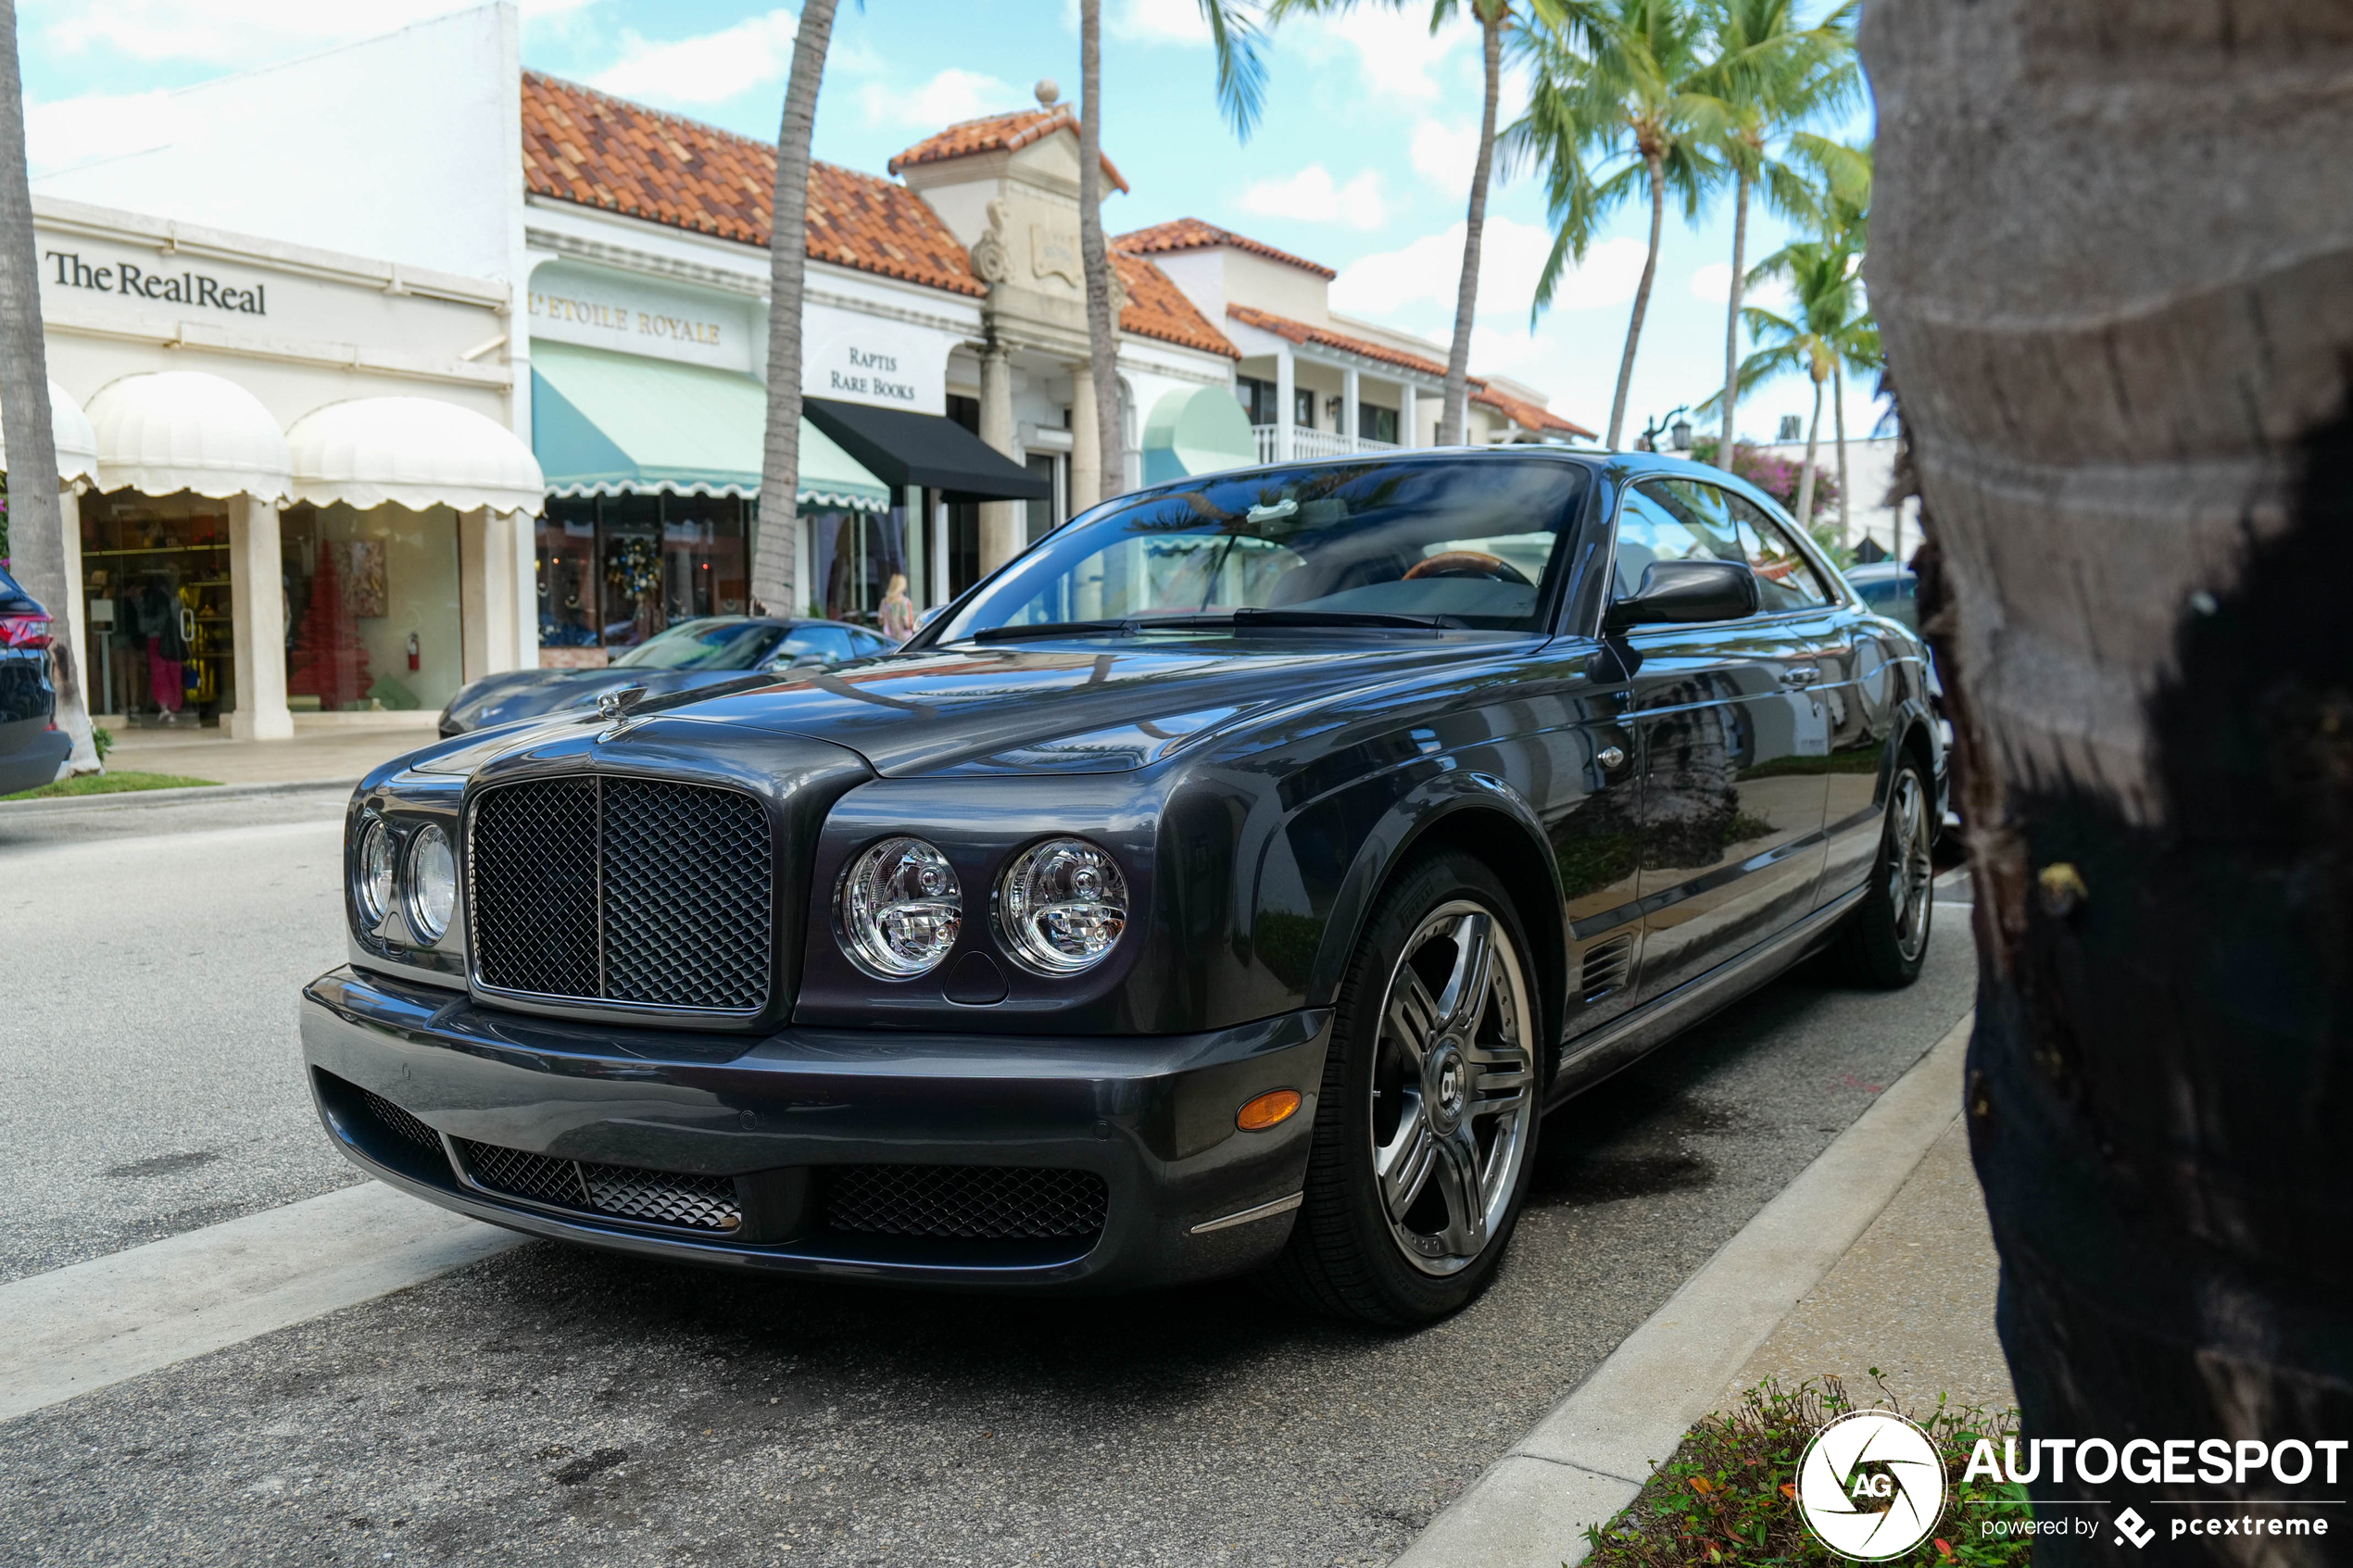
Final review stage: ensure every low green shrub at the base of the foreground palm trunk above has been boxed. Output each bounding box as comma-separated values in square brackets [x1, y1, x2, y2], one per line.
[1586, 1373, 2033, 1568]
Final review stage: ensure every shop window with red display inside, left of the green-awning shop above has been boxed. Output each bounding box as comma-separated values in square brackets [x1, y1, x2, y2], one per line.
[278, 503, 466, 712]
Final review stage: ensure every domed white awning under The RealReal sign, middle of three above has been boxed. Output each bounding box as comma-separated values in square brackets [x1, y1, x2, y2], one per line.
[90, 370, 292, 501]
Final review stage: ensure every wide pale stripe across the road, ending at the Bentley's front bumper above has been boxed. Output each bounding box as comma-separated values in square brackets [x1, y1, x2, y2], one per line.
[0, 1183, 522, 1420]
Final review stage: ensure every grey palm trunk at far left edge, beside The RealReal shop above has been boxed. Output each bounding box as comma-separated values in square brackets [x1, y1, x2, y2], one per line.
[0, 0, 90, 773]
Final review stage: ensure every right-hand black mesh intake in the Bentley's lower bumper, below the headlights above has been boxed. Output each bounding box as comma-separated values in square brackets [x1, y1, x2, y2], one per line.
[826, 1166, 1108, 1239]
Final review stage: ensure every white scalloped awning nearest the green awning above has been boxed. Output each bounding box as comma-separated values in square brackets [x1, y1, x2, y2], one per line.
[287, 397, 548, 512]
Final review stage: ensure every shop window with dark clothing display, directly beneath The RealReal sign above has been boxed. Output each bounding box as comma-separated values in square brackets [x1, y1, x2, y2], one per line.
[82, 489, 238, 724]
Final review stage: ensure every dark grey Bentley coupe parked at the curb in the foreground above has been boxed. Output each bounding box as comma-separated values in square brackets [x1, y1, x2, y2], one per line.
[301, 449, 1944, 1323]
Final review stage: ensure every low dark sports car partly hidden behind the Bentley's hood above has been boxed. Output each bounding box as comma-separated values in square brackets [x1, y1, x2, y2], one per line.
[440, 616, 899, 735]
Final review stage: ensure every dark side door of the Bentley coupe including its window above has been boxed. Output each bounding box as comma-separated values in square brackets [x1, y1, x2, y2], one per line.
[1617, 477, 1829, 999]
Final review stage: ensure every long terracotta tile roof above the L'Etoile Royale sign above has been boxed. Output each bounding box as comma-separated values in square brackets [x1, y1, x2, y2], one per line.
[522, 70, 988, 296]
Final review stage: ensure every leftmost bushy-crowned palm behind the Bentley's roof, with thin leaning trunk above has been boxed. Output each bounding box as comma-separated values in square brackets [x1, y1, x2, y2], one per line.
[1506, 0, 1725, 449]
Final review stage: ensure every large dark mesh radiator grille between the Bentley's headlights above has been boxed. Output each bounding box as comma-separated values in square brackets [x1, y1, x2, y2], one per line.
[466, 776, 774, 1013]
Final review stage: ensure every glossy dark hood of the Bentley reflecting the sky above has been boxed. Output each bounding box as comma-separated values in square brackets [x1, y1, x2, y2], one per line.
[663, 634, 1525, 776]
